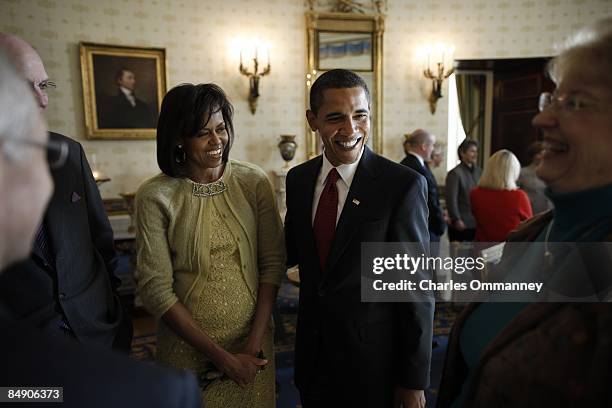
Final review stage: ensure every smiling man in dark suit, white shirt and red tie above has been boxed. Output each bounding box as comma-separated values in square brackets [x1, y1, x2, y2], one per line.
[285, 70, 433, 408]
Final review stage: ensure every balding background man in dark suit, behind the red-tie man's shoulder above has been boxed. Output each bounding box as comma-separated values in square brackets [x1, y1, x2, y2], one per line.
[401, 129, 446, 247]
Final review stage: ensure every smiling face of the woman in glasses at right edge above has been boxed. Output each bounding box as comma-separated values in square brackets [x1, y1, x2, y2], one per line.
[533, 64, 612, 192]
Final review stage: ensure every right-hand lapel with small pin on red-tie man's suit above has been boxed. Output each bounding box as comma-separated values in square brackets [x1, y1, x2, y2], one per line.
[323, 147, 377, 280]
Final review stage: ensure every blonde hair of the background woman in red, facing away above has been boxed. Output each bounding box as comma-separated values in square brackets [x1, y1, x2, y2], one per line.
[478, 149, 521, 190]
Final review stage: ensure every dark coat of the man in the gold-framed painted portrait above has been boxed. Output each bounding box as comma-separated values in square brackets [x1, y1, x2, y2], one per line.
[100, 91, 157, 129]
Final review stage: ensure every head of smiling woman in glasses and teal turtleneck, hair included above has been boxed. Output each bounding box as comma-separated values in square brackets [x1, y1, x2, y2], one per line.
[533, 19, 612, 193]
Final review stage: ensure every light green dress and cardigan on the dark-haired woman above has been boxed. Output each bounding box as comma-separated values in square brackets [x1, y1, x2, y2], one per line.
[135, 160, 286, 408]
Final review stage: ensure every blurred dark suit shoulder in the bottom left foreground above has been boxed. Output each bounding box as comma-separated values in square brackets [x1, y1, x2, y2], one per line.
[0, 310, 202, 408]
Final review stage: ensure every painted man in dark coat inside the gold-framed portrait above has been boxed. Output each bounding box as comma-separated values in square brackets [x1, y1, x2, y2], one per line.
[100, 67, 157, 129]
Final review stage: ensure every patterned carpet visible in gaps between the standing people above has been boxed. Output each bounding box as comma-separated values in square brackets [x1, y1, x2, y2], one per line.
[132, 281, 460, 408]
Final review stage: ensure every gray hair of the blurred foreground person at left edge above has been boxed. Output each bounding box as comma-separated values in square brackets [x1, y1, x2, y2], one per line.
[0, 49, 38, 160]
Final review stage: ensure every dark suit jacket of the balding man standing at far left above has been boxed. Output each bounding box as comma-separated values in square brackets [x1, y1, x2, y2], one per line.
[0, 133, 132, 351]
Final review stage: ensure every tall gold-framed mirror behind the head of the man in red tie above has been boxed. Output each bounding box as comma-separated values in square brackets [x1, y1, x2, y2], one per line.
[306, 10, 385, 159]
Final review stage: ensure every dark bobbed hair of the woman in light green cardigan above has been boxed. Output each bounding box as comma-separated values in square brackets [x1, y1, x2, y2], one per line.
[157, 84, 234, 177]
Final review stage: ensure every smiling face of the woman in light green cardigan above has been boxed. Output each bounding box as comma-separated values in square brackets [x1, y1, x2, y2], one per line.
[183, 110, 229, 178]
